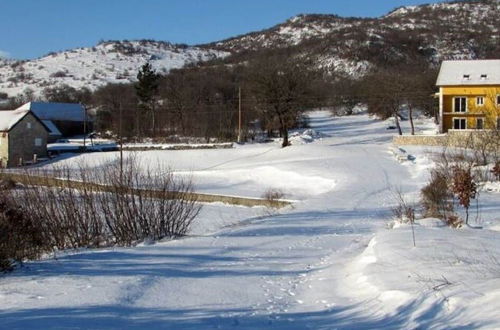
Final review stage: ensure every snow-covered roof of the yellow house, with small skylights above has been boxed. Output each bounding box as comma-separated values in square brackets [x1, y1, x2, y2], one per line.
[436, 60, 500, 86]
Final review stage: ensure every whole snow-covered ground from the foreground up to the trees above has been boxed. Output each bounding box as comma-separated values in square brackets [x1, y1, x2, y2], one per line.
[0, 112, 500, 329]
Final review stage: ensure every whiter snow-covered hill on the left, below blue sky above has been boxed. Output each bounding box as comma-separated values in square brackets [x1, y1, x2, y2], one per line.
[0, 40, 229, 96]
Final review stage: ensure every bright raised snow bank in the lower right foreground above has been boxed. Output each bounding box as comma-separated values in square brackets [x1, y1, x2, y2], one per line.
[343, 224, 500, 328]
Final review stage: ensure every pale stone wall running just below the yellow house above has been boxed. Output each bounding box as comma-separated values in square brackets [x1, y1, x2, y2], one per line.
[392, 130, 500, 149]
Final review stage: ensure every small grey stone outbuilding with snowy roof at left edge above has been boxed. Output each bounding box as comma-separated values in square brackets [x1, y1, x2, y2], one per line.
[0, 109, 50, 167]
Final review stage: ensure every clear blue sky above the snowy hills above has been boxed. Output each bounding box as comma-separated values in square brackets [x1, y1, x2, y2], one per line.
[0, 0, 438, 59]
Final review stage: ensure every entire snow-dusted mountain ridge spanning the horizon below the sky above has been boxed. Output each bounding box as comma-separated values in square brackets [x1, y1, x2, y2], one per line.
[0, 0, 500, 96]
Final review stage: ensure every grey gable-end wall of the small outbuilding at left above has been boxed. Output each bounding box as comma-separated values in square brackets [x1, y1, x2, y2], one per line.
[7, 113, 49, 167]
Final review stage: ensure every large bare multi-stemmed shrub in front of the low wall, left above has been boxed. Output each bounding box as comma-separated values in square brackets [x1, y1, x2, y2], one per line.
[2, 158, 201, 249]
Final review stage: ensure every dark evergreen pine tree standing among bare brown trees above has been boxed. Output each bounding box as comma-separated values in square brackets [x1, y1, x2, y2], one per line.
[135, 62, 160, 136]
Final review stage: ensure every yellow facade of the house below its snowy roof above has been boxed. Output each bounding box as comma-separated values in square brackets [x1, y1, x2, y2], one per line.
[442, 85, 500, 132]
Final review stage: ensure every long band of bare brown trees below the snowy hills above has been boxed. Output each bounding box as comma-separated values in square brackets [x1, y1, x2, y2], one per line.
[0, 50, 437, 146]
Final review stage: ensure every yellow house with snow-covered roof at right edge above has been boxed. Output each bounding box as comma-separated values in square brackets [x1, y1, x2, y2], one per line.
[436, 60, 500, 133]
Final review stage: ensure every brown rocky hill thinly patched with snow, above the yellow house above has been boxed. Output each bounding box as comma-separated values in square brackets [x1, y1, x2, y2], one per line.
[207, 0, 500, 76]
